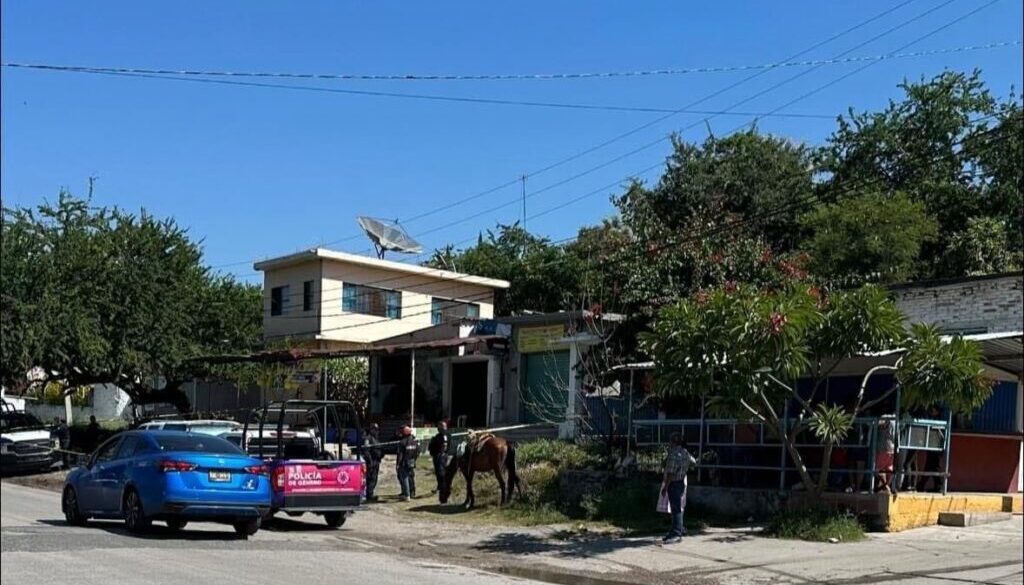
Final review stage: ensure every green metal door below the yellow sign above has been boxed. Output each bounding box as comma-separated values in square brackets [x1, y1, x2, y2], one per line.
[519, 351, 571, 423]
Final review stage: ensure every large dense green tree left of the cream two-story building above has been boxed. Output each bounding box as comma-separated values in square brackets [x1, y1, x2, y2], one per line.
[0, 193, 262, 408]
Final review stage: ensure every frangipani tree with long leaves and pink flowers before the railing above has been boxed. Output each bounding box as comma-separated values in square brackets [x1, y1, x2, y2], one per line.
[642, 286, 991, 495]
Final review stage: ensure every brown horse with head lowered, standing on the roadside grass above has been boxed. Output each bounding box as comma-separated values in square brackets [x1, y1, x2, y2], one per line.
[437, 434, 522, 509]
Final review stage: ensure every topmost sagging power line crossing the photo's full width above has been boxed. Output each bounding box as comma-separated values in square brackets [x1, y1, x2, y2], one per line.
[3, 41, 1021, 81]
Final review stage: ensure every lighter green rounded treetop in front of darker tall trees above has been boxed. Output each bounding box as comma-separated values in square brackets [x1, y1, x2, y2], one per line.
[802, 193, 938, 285]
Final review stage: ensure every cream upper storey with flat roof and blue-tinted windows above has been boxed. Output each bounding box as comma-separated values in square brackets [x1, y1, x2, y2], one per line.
[254, 248, 509, 349]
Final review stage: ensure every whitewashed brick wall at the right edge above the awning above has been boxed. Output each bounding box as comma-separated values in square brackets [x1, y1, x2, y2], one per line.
[892, 273, 1024, 333]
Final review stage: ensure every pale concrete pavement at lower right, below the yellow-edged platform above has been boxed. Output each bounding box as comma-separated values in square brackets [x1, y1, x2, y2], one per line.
[423, 515, 1024, 585]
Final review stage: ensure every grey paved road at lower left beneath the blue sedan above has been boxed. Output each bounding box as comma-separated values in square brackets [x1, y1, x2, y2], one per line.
[0, 483, 528, 585]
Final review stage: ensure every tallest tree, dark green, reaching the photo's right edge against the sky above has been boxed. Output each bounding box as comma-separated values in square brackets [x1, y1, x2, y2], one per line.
[817, 71, 1024, 277]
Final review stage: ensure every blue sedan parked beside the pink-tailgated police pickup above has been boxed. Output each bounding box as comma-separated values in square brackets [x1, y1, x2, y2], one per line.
[61, 430, 270, 536]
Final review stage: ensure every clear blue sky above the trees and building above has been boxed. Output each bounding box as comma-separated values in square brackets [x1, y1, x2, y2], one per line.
[0, 0, 1022, 279]
